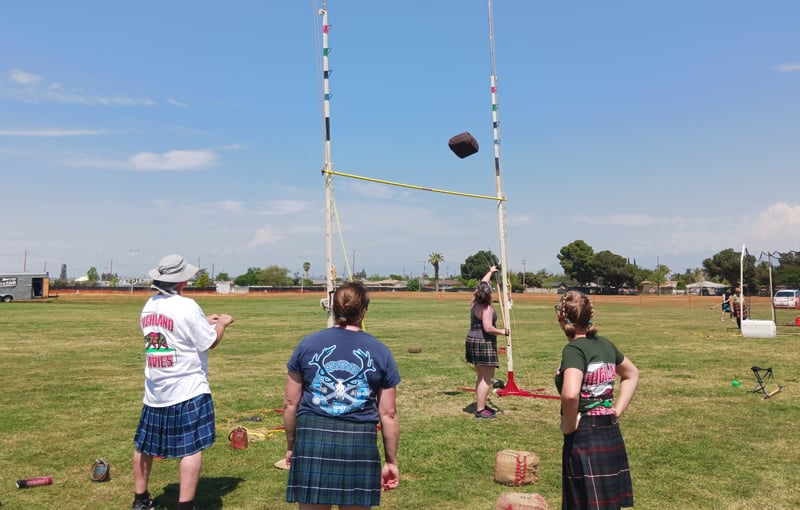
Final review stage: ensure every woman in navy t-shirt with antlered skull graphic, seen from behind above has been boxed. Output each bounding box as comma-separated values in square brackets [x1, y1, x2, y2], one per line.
[283, 282, 400, 510]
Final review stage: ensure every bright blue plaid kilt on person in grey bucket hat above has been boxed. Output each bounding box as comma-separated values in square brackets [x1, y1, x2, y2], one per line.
[133, 394, 216, 459]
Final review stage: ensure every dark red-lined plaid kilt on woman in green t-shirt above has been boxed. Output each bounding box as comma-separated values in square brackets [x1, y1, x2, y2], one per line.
[561, 416, 633, 510]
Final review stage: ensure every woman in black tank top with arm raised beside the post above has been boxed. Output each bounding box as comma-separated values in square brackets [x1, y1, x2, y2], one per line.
[465, 266, 510, 420]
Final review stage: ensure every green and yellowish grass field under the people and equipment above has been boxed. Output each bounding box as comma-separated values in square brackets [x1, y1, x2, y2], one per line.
[0, 293, 800, 510]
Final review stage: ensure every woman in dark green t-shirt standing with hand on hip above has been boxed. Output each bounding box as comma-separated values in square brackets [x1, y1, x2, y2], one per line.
[556, 291, 639, 510]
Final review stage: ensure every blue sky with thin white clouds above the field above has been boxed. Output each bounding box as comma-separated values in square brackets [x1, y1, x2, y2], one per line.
[0, 0, 800, 278]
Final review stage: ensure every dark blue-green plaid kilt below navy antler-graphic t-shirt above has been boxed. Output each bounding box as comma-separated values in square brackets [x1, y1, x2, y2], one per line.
[286, 413, 382, 507]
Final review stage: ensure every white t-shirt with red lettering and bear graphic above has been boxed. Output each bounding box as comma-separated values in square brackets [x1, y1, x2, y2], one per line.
[141, 294, 217, 407]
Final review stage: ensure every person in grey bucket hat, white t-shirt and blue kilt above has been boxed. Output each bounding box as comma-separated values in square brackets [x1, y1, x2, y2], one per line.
[131, 255, 233, 510]
